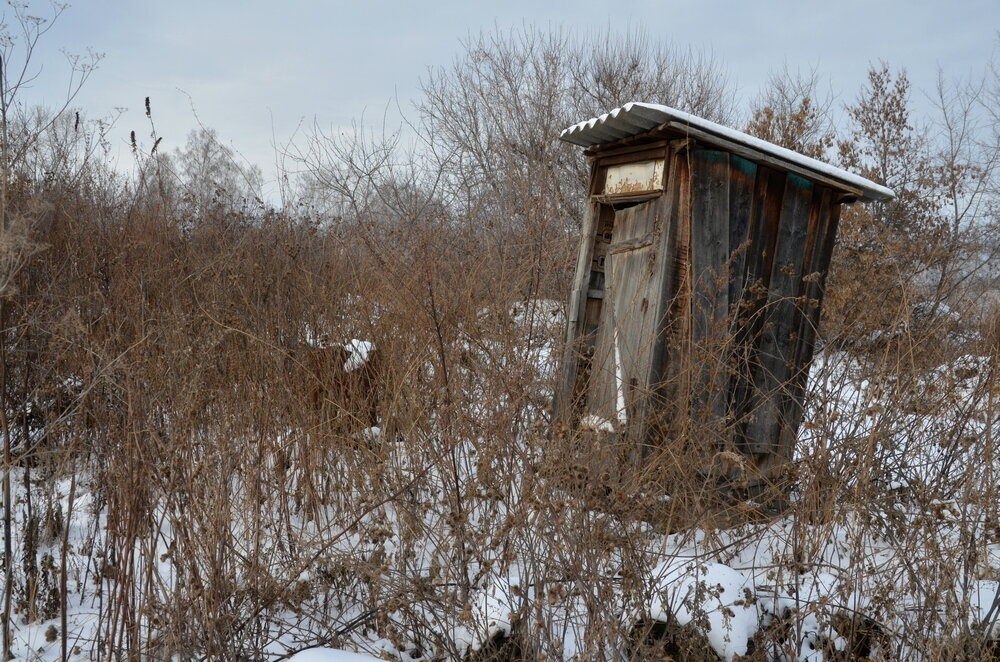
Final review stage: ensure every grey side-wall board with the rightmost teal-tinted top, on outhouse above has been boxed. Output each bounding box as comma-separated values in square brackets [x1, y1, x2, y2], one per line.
[747, 174, 814, 454]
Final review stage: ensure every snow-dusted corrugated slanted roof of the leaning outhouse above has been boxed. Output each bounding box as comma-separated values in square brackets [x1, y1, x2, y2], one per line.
[559, 101, 896, 200]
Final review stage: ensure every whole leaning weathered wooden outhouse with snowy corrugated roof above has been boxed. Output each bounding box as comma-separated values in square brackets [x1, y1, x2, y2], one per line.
[556, 103, 893, 488]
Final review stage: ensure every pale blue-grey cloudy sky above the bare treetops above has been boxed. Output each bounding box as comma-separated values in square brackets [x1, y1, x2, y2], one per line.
[15, 0, 1000, 197]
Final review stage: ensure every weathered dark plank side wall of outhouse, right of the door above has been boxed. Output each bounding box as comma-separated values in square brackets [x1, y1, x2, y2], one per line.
[674, 148, 840, 460]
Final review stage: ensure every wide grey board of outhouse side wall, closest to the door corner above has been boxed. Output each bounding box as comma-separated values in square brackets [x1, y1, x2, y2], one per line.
[691, 149, 730, 421]
